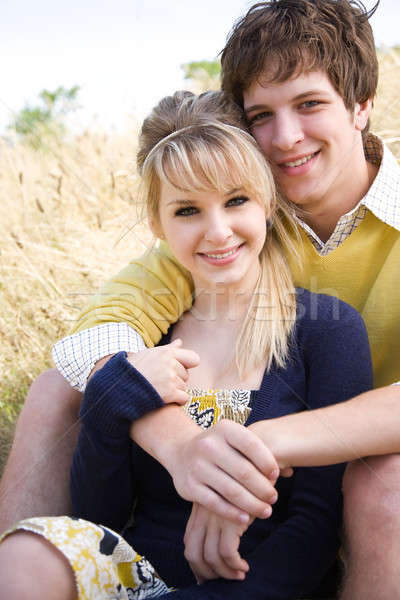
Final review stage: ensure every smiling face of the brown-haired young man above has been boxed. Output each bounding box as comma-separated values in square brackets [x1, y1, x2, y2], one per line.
[243, 71, 370, 214]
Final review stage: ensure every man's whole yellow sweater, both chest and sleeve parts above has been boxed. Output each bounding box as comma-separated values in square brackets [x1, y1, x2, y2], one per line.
[73, 212, 400, 387]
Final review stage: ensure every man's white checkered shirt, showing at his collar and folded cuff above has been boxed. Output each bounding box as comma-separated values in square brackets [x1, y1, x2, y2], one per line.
[53, 134, 400, 391]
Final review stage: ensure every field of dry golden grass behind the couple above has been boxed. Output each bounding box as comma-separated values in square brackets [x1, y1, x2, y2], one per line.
[0, 51, 400, 472]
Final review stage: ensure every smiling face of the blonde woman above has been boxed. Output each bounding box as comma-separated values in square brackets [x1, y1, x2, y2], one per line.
[153, 178, 266, 291]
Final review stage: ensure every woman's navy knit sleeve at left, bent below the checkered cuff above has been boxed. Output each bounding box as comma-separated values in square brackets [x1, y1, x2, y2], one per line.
[70, 352, 163, 531]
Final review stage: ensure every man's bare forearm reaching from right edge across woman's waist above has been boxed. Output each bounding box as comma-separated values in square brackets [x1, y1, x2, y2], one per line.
[250, 385, 400, 467]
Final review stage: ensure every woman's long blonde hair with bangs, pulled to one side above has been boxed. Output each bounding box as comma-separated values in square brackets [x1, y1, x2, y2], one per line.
[138, 92, 296, 375]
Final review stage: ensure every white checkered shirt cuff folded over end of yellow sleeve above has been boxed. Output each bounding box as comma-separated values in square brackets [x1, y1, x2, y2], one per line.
[52, 323, 146, 392]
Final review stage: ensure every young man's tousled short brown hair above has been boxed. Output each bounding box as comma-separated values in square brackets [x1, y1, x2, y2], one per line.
[221, 0, 379, 119]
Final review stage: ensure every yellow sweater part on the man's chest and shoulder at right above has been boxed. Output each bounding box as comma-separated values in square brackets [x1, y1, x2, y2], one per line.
[288, 211, 400, 387]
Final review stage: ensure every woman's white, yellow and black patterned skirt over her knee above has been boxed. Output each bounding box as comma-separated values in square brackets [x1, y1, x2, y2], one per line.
[0, 517, 174, 600]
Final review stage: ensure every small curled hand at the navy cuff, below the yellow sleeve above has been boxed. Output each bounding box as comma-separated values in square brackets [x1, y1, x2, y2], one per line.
[128, 339, 200, 405]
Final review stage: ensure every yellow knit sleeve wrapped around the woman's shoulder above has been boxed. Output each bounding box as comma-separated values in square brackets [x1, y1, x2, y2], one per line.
[71, 243, 193, 347]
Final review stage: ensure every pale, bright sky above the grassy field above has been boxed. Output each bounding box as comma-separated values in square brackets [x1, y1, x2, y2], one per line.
[0, 0, 400, 130]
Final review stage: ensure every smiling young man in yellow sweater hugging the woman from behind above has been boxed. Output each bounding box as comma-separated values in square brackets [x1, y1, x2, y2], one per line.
[2, 0, 400, 600]
